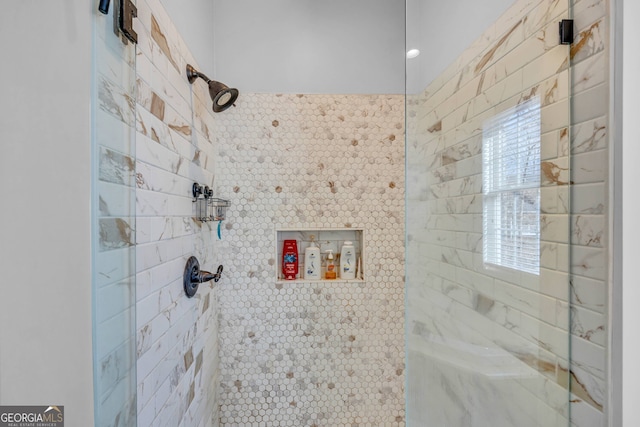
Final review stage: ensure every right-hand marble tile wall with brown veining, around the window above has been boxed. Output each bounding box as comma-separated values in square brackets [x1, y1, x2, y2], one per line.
[407, 0, 608, 426]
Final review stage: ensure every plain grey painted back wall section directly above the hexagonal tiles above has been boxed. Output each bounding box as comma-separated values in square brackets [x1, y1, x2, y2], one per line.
[212, 0, 405, 94]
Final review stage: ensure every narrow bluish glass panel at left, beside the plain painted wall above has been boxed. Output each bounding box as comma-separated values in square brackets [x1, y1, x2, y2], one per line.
[91, 2, 137, 427]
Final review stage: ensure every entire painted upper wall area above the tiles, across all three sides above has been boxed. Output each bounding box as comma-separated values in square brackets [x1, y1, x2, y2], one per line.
[162, 0, 514, 93]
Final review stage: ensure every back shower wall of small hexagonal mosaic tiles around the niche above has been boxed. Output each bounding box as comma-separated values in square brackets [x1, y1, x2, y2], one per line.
[215, 93, 405, 427]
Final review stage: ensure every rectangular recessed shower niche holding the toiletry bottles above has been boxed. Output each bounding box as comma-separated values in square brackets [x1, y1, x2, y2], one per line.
[275, 228, 367, 282]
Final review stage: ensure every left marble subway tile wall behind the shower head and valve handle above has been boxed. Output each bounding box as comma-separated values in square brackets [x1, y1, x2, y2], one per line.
[127, 0, 221, 427]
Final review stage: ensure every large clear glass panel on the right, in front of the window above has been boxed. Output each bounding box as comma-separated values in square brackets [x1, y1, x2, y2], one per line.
[406, 0, 570, 427]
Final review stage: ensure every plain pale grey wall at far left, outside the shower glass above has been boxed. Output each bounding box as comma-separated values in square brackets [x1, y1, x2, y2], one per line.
[0, 0, 97, 426]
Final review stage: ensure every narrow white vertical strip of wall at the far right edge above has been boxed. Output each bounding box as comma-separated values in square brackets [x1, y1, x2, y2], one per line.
[622, 0, 640, 427]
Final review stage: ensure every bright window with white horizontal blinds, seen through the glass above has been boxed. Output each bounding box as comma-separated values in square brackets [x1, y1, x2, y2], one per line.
[482, 97, 540, 274]
